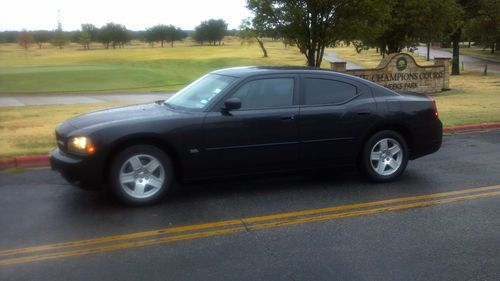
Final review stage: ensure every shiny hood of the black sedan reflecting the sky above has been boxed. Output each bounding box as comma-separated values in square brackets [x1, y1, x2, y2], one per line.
[67, 103, 178, 129]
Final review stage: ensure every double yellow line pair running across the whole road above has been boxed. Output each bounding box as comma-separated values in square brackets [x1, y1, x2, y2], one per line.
[0, 185, 500, 266]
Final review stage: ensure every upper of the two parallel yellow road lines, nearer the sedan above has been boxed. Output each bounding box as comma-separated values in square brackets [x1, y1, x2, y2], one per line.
[0, 185, 500, 258]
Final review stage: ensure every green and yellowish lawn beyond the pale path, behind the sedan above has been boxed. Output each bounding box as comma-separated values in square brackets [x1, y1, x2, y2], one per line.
[0, 40, 305, 95]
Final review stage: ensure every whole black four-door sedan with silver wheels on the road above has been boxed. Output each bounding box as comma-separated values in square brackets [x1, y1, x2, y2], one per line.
[50, 67, 442, 205]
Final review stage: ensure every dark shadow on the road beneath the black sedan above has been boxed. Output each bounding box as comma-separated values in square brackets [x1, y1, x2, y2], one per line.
[62, 165, 434, 212]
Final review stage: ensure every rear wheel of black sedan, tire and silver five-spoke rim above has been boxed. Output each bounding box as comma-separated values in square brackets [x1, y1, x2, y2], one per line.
[359, 130, 408, 182]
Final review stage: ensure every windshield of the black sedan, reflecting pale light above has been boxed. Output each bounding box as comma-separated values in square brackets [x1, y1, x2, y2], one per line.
[165, 74, 236, 110]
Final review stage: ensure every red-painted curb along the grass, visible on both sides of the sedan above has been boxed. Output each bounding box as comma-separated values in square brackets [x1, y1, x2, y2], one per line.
[0, 122, 500, 170]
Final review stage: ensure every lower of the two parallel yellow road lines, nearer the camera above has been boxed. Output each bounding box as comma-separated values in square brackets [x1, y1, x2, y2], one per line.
[0, 188, 500, 266]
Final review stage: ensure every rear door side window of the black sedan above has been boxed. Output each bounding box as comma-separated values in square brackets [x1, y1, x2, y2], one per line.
[304, 78, 358, 105]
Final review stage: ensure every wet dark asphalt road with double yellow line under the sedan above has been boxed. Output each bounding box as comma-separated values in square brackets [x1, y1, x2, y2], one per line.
[0, 131, 500, 281]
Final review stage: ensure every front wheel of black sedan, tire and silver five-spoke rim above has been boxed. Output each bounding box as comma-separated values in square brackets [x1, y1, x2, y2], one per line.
[109, 145, 175, 206]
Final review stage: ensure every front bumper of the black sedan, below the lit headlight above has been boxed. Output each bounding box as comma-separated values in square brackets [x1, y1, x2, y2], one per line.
[49, 148, 103, 189]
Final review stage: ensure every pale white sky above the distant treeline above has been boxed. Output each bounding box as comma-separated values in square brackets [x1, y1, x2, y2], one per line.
[0, 0, 251, 31]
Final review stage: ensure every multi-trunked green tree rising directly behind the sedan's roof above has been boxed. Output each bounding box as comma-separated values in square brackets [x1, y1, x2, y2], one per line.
[247, 0, 387, 67]
